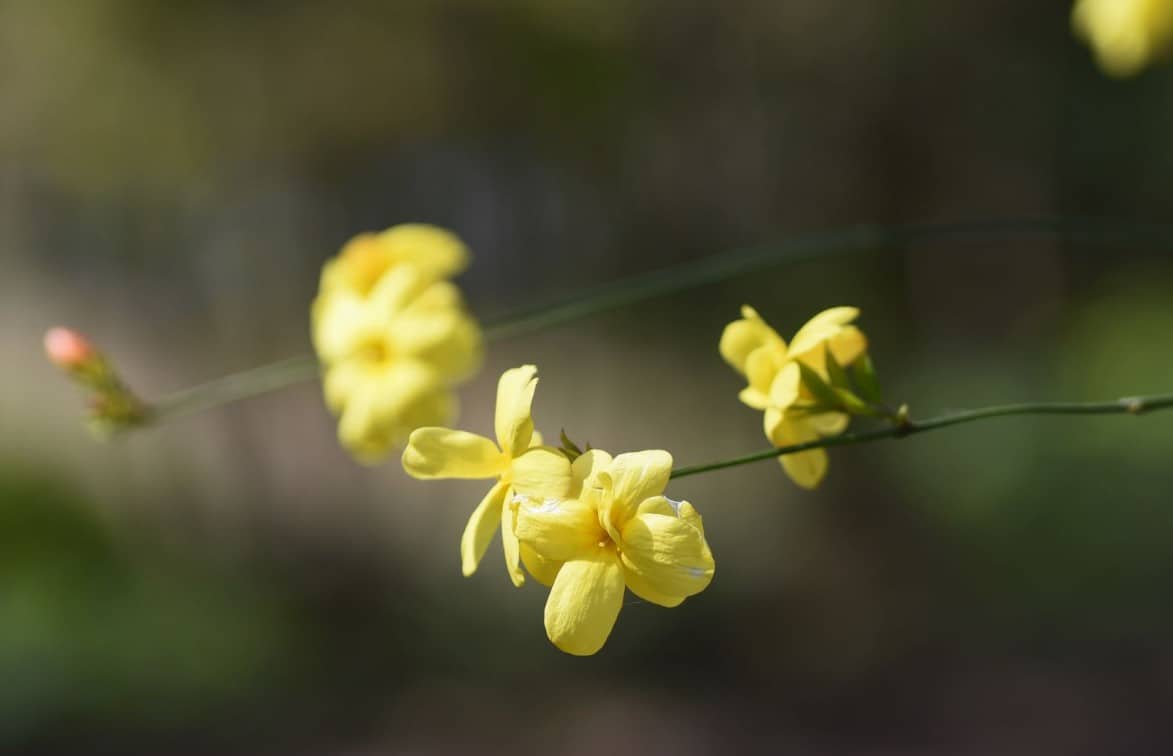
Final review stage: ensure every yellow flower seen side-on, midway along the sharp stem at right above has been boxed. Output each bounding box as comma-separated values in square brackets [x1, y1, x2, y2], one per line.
[719, 305, 867, 489]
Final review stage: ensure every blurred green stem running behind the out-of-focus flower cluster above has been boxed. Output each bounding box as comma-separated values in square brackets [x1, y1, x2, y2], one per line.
[150, 218, 1173, 422]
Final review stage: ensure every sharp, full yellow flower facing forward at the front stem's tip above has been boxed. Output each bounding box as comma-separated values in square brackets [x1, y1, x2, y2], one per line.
[516, 449, 716, 656]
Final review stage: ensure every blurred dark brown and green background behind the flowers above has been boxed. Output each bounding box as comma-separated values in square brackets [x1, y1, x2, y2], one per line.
[0, 0, 1173, 756]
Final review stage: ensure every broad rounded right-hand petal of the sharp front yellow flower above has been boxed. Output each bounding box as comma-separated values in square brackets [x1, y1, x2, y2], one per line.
[622, 506, 714, 601]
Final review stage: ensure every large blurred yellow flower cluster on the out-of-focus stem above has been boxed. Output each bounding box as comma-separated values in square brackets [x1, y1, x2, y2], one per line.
[311, 224, 482, 462]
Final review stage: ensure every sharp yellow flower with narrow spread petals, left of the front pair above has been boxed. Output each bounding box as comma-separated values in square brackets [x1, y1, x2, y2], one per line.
[404, 365, 571, 586]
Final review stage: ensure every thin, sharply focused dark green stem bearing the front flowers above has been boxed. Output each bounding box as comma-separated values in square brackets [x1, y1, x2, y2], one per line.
[672, 394, 1173, 478]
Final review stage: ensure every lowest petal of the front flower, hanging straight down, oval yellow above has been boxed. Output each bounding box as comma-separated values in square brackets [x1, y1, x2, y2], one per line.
[545, 541, 624, 656]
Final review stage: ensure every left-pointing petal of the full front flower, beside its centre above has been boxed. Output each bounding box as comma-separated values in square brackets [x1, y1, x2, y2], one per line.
[515, 496, 606, 561]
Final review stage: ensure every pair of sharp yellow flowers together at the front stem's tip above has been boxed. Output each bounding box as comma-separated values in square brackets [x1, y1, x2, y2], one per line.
[404, 366, 714, 655]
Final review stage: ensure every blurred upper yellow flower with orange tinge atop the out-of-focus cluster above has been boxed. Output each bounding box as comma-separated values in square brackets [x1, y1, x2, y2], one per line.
[321, 223, 469, 295]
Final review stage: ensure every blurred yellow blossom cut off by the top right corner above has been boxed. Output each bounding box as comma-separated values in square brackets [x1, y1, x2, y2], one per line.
[1071, 0, 1173, 76]
